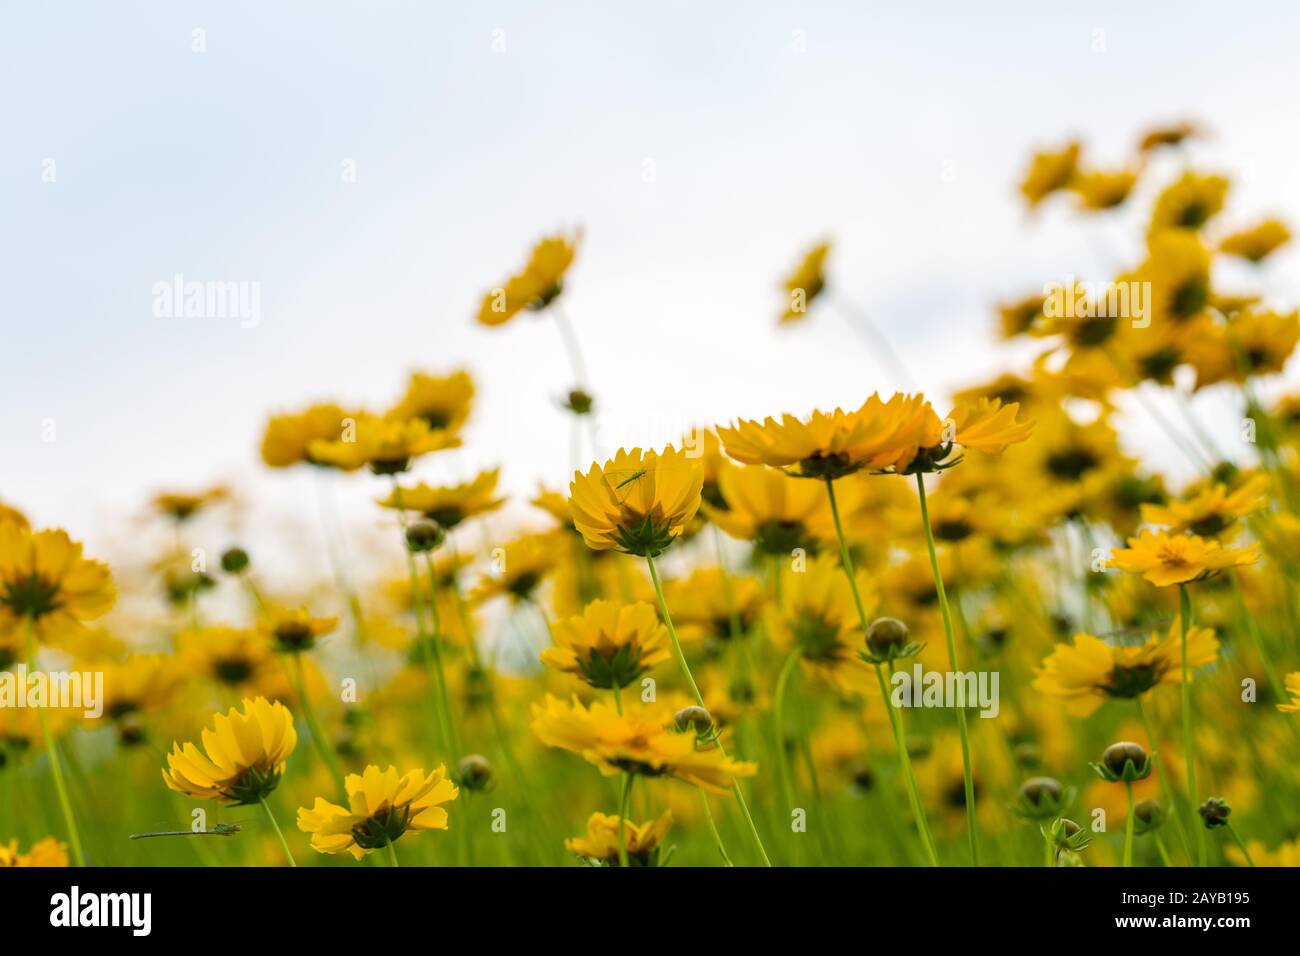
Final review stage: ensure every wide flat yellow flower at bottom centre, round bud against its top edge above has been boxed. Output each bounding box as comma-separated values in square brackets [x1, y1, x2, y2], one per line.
[532, 695, 758, 793]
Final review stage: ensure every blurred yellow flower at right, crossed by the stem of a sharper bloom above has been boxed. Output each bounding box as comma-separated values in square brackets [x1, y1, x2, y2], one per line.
[1034, 619, 1219, 717]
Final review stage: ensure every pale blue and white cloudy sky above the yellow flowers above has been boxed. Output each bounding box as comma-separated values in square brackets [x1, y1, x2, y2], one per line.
[0, 0, 1300, 567]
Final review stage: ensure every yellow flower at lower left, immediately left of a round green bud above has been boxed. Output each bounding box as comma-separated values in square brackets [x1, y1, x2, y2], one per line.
[298, 765, 460, 860]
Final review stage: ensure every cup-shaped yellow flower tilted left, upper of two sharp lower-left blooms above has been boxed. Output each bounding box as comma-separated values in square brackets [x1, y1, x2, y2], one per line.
[163, 697, 298, 806]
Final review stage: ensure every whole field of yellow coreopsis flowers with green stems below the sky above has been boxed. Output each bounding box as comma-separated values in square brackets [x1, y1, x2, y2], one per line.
[0, 125, 1300, 866]
